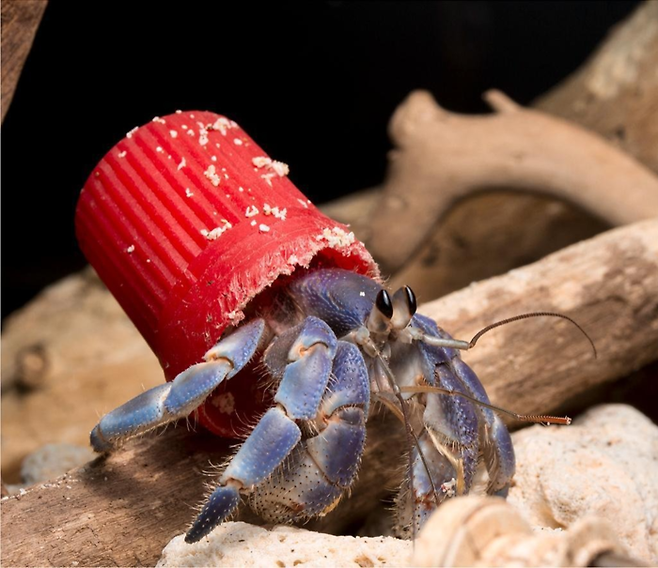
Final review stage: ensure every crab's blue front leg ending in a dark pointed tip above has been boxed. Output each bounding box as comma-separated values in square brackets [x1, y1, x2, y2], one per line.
[185, 316, 337, 543]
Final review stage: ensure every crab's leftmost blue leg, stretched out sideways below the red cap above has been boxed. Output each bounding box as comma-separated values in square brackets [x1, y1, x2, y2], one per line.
[91, 319, 265, 452]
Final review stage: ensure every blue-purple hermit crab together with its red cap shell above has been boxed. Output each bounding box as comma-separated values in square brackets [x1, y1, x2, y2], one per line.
[76, 112, 580, 542]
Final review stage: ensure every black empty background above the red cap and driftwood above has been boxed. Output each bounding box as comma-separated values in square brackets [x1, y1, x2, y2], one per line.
[2, 0, 637, 318]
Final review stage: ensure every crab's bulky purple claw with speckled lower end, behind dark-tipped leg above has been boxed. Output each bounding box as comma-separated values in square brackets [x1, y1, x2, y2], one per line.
[249, 341, 370, 523]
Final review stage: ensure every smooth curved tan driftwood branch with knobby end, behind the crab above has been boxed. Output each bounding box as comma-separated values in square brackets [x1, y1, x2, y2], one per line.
[365, 91, 658, 274]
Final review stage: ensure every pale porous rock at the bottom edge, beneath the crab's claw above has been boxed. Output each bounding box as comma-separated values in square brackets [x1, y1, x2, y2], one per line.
[157, 522, 412, 568]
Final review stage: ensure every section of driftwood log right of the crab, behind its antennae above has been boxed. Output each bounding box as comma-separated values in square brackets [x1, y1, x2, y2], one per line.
[423, 219, 658, 413]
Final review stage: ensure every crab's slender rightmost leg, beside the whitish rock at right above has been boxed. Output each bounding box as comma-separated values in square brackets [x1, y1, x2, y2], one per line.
[453, 358, 516, 497]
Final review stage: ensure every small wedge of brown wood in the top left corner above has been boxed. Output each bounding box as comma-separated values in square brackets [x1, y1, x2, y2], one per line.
[2, 0, 48, 120]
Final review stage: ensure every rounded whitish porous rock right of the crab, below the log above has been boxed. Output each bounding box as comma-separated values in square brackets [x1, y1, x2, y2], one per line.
[508, 404, 658, 564]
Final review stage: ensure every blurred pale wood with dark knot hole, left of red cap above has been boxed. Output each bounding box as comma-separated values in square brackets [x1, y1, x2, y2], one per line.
[1, 269, 163, 483]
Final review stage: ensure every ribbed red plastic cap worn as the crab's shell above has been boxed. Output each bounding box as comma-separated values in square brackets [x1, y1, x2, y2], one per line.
[76, 111, 378, 436]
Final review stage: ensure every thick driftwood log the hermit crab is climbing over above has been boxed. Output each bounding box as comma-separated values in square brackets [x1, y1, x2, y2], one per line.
[2, 220, 658, 566]
